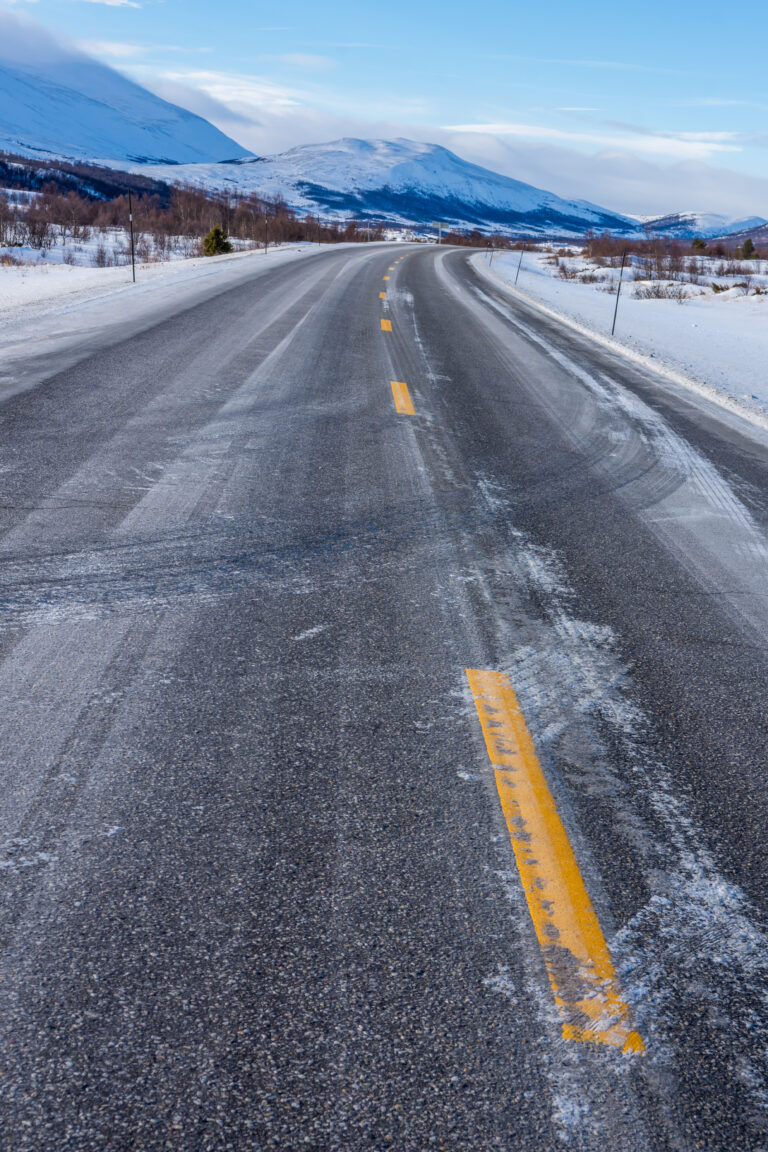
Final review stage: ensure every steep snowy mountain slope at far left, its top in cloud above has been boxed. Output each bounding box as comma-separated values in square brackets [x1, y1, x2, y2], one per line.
[0, 13, 250, 166]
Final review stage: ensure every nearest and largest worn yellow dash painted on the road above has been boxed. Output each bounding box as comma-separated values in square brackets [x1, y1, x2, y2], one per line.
[465, 668, 645, 1052]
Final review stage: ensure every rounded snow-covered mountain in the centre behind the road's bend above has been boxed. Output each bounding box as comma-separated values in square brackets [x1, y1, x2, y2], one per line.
[142, 138, 637, 236]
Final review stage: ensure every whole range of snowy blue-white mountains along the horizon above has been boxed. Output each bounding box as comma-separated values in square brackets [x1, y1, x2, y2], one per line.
[0, 45, 766, 238]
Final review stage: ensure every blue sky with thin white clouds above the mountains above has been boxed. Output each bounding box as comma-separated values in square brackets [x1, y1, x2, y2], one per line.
[4, 0, 768, 215]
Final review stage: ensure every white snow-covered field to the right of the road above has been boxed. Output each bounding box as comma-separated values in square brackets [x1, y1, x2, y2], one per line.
[474, 252, 768, 423]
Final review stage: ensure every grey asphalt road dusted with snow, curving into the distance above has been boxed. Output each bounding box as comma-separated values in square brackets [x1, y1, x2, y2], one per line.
[0, 245, 768, 1152]
